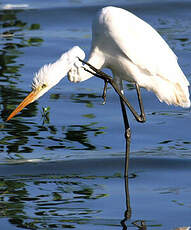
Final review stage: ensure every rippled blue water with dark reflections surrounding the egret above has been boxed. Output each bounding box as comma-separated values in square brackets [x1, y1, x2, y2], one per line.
[0, 0, 191, 230]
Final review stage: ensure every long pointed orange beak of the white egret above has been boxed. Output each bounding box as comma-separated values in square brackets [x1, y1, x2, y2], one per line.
[6, 89, 39, 121]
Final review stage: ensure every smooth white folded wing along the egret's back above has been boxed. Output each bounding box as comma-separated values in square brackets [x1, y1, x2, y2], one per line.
[104, 7, 189, 85]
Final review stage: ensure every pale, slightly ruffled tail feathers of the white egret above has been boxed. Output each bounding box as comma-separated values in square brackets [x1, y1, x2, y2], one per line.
[152, 79, 190, 108]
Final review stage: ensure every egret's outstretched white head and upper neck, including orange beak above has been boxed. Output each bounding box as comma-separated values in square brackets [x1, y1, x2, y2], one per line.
[6, 46, 85, 121]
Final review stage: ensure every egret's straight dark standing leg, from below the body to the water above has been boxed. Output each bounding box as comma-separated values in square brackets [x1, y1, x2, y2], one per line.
[120, 98, 131, 177]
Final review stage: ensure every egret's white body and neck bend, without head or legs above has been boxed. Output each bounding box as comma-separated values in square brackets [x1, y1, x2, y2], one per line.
[69, 6, 190, 107]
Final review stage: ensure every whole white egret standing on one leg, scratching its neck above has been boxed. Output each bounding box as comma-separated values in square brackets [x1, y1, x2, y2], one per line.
[7, 6, 190, 176]
